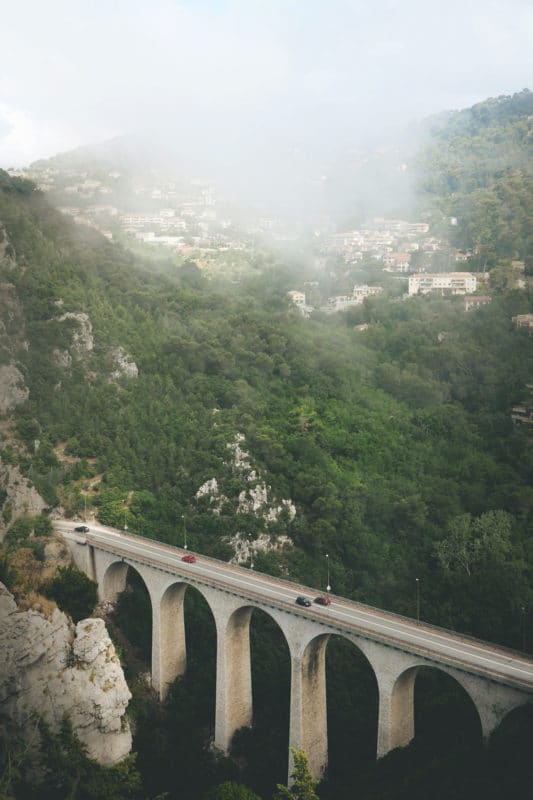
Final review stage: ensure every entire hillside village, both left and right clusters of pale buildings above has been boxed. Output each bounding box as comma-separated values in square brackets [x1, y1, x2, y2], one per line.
[11, 166, 526, 328]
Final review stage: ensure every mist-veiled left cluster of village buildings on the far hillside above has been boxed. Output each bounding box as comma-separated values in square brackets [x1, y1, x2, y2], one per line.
[10, 162, 308, 258]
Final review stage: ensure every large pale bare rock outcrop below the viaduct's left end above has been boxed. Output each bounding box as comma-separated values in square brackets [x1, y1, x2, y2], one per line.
[0, 583, 131, 766]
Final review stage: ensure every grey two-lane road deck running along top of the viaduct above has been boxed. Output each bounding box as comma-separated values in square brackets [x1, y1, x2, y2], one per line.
[54, 520, 533, 692]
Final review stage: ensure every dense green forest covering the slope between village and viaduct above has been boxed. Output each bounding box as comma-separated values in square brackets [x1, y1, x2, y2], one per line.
[0, 164, 533, 646]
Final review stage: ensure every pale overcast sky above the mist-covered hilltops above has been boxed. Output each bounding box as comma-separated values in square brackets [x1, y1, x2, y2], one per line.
[0, 0, 533, 167]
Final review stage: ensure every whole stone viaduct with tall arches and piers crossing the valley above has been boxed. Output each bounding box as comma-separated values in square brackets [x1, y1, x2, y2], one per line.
[60, 523, 533, 778]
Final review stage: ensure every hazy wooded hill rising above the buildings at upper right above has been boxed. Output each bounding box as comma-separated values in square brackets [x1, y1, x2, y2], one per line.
[419, 89, 533, 268]
